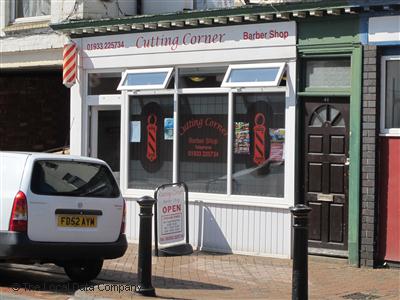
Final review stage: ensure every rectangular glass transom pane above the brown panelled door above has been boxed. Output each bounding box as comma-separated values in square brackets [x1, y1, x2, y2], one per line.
[305, 59, 351, 89]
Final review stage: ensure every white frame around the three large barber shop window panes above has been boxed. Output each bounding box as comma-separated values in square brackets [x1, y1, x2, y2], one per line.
[120, 62, 296, 209]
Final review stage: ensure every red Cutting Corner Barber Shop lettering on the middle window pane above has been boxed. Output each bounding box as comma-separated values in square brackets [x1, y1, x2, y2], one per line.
[179, 115, 228, 162]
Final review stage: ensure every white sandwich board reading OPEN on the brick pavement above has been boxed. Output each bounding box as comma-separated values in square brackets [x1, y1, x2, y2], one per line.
[154, 182, 193, 256]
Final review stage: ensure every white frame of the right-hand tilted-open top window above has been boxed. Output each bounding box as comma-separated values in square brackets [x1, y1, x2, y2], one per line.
[221, 62, 286, 87]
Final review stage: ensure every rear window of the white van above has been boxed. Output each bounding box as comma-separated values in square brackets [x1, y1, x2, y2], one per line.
[31, 160, 120, 198]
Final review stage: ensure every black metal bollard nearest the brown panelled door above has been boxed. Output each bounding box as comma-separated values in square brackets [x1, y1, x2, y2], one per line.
[290, 204, 311, 300]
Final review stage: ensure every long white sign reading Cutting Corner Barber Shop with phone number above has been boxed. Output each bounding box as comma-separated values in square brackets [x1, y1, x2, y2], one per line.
[82, 22, 296, 57]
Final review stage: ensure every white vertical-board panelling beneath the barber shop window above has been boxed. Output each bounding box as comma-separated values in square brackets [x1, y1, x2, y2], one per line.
[126, 199, 291, 258]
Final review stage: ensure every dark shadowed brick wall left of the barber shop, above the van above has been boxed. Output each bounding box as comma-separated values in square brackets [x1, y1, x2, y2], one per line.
[0, 71, 70, 152]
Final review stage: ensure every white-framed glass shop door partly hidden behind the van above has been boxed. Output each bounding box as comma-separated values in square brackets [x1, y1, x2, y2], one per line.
[90, 106, 121, 183]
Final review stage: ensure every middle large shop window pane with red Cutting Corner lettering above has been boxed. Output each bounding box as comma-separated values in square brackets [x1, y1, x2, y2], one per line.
[178, 94, 228, 194]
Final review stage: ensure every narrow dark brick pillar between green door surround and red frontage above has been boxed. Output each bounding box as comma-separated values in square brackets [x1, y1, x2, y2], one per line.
[360, 46, 379, 267]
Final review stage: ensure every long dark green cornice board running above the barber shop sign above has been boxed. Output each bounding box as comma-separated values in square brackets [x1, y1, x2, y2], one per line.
[50, 0, 374, 30]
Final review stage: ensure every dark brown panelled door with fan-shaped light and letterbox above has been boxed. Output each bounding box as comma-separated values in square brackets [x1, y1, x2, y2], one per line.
[302, 97, 350, 256]
